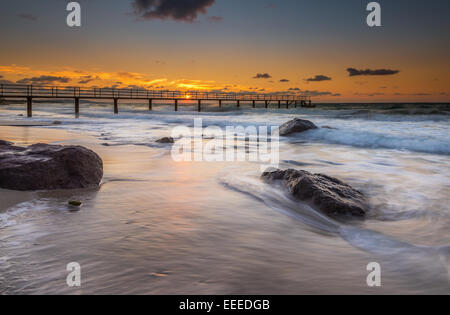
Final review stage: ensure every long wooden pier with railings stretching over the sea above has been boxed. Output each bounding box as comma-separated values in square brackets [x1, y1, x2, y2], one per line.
[0, 84, 313, 117]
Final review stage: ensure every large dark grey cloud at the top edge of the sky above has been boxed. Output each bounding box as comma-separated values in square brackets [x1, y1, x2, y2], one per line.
[132, 0, 215, 22]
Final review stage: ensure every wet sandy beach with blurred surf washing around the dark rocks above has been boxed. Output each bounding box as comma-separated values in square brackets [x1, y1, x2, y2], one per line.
[0, 102, 450, 294]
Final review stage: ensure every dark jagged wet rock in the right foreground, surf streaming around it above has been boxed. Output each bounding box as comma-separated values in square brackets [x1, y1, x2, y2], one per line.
[262, 169, 368, 217]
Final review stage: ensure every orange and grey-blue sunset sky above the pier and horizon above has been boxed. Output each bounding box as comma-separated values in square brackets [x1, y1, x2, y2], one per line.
[0, 0, 450, 102]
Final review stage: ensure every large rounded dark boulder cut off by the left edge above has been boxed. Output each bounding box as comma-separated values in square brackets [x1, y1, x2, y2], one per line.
[0, 144, 103, 191]
